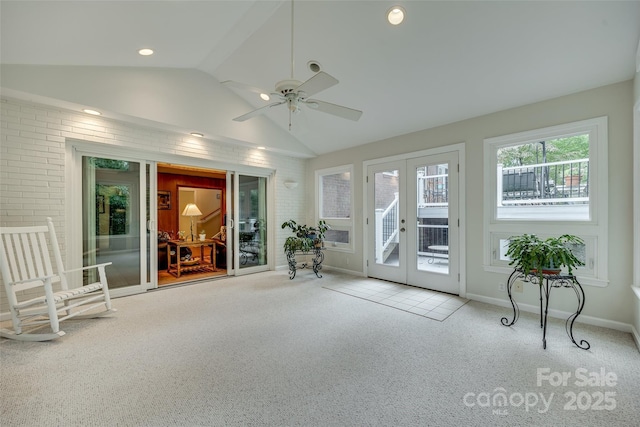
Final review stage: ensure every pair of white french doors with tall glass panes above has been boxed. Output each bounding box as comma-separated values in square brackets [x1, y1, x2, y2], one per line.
[367, 151, 460, 294]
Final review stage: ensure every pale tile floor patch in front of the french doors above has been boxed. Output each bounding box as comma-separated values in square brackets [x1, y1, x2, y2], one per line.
[324, 279, 469, 321]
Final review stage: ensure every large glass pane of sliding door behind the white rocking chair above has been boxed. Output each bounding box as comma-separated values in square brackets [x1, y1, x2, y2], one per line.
[82, 156, 141, 288]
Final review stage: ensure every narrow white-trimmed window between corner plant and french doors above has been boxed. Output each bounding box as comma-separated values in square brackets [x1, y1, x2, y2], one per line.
[316, 165, 353, 252]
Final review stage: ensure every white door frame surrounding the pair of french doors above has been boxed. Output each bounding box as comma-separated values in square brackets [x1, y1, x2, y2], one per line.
[362, 143, 467, 297]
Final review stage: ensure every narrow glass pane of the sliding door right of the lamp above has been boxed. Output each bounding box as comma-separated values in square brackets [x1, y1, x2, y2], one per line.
[238, 175, 267, 269]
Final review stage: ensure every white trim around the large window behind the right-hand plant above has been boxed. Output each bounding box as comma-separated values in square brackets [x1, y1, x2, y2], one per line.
[483, 116, 609, 287]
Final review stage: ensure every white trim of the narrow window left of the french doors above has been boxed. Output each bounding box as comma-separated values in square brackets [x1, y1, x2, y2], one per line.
[315, 164, 355, 253]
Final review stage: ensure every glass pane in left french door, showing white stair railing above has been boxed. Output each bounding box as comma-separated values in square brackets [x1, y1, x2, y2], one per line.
[373, 169, 400, 266]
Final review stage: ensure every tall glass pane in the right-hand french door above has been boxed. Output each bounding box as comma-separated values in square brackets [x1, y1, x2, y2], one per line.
[415, 163, 449, 274]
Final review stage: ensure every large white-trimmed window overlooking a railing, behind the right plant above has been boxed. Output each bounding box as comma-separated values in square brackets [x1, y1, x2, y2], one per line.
[484, 117, 608, 286]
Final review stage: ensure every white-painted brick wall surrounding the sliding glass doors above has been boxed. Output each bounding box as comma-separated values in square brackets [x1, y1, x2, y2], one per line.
[0, 98, 307, 313]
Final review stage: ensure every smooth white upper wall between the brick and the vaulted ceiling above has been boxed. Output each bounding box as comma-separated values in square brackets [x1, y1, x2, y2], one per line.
[0, 64, 313, 158]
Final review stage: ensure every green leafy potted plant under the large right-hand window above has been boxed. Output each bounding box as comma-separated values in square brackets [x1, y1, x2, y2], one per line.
[506, 234, 584, 279]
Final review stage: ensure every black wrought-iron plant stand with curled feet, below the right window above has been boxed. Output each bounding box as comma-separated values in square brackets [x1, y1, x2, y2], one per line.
[500, 270, 591, 350]
